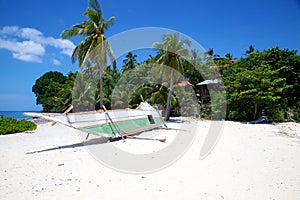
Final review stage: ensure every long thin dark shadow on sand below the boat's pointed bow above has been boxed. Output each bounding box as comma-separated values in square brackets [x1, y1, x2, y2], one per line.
[26, 137, 116, 154]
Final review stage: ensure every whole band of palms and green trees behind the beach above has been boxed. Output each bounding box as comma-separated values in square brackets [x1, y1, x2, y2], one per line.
[32, 0, 300, 121]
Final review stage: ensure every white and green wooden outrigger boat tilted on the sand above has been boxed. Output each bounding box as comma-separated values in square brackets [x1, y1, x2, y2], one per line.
[23, 102, 167, 142]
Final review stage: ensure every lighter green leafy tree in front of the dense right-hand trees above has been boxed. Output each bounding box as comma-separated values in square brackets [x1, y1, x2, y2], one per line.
[223, 65, 287, 121]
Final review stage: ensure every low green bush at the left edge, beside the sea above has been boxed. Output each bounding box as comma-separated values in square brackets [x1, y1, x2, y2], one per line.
[0, 116, 37, 135]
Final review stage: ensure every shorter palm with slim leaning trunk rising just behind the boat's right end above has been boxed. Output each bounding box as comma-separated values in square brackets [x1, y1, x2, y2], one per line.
[154, 33, 190, 121]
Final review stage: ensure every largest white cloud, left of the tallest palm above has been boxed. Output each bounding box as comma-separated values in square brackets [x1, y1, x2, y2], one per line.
[0, 26, 75, 63]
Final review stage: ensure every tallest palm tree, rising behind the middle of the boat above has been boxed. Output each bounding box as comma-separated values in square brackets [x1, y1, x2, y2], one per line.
[62, 0, 115, 108]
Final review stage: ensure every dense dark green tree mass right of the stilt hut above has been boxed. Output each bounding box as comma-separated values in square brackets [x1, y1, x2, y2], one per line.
[222, 46, 300, 121]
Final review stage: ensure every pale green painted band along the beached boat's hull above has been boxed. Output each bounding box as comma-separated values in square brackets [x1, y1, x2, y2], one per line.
[81, 118, 162, 136]
